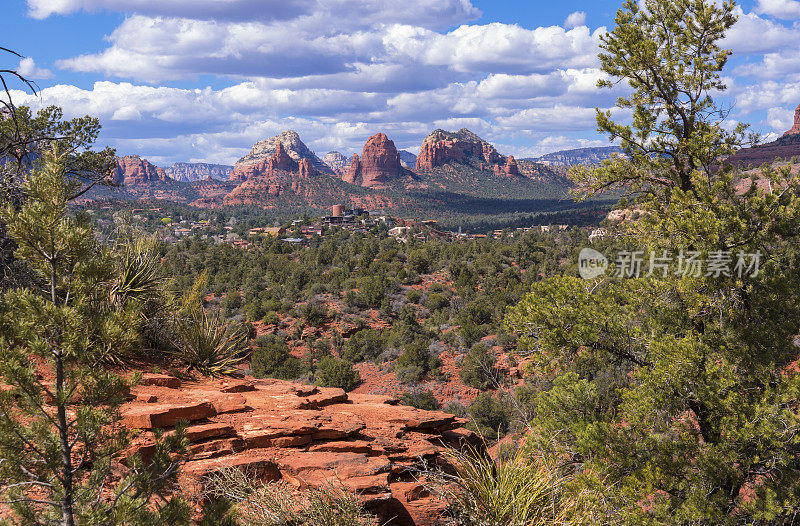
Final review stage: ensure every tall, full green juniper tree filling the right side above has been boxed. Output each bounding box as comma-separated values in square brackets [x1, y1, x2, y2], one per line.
[507, 0, 800, 524]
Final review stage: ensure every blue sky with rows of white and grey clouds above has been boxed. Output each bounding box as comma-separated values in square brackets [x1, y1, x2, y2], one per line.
[0, 0, 800, 165]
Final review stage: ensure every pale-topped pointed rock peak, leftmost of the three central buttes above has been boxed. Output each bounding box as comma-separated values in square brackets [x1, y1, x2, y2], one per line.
[231, 130, 333, 181]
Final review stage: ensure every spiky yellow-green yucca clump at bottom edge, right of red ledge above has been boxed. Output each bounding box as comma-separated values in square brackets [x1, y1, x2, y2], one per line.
[429, 447, 585, 526]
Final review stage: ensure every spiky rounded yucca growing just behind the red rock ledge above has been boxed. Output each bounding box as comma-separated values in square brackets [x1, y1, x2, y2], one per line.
[176, 311, 248, 376]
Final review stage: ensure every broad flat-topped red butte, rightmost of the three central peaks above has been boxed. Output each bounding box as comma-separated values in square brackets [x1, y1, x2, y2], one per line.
[417, 128, 502, 171]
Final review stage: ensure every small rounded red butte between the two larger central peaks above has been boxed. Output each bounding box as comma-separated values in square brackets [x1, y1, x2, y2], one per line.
[344, 133, 405, 188]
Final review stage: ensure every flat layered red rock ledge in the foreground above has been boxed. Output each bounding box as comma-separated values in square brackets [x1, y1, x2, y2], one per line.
[122, 378, 480, 525]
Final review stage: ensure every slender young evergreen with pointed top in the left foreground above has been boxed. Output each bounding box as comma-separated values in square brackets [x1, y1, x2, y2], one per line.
[0, 151, 188, 526]
